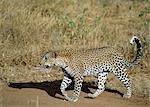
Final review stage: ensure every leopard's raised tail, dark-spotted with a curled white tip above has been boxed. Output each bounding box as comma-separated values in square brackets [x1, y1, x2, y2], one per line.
[130, 36, 143, 66]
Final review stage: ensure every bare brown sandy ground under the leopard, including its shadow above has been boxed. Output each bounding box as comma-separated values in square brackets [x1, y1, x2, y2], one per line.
[0, 81, 150, 107]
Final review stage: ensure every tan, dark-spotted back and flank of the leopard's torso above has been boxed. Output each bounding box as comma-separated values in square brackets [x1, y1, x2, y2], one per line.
[60, 47, 127, 73]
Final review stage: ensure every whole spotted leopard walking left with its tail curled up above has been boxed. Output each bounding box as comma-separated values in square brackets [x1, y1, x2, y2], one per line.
[40, 35, 143, 102]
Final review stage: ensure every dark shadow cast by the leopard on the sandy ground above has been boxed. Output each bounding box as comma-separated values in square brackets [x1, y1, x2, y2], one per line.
[9, 80, 123, 100]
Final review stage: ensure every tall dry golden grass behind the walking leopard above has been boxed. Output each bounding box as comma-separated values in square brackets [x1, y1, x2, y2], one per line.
[0, 0, 150, 95]
